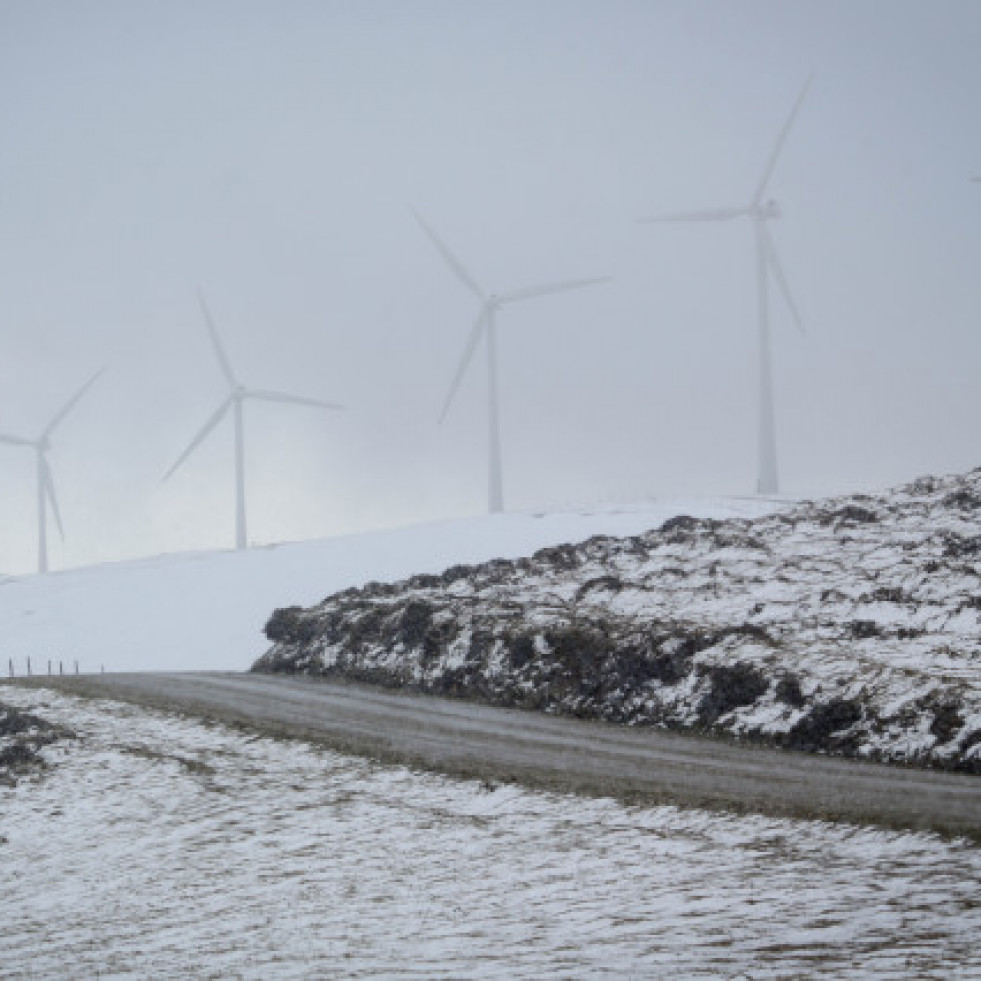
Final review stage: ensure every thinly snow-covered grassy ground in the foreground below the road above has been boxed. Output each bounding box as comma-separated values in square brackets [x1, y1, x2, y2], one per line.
[0, 686, 981, 978]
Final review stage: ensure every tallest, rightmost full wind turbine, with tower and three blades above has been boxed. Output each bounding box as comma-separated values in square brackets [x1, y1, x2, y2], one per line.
[642, 78, 811, 494]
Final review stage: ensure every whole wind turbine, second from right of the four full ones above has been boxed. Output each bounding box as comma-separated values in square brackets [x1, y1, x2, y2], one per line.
[412, 211, 611, 514]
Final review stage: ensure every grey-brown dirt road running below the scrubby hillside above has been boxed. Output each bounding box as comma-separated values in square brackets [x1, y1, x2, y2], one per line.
[9, 673, 981, 840]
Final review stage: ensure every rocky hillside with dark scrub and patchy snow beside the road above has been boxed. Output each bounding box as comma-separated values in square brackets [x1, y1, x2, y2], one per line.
[253, 469, 981, 772]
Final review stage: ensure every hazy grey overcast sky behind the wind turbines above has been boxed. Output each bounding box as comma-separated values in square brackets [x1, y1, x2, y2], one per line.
[0, 0, 981, 572]
